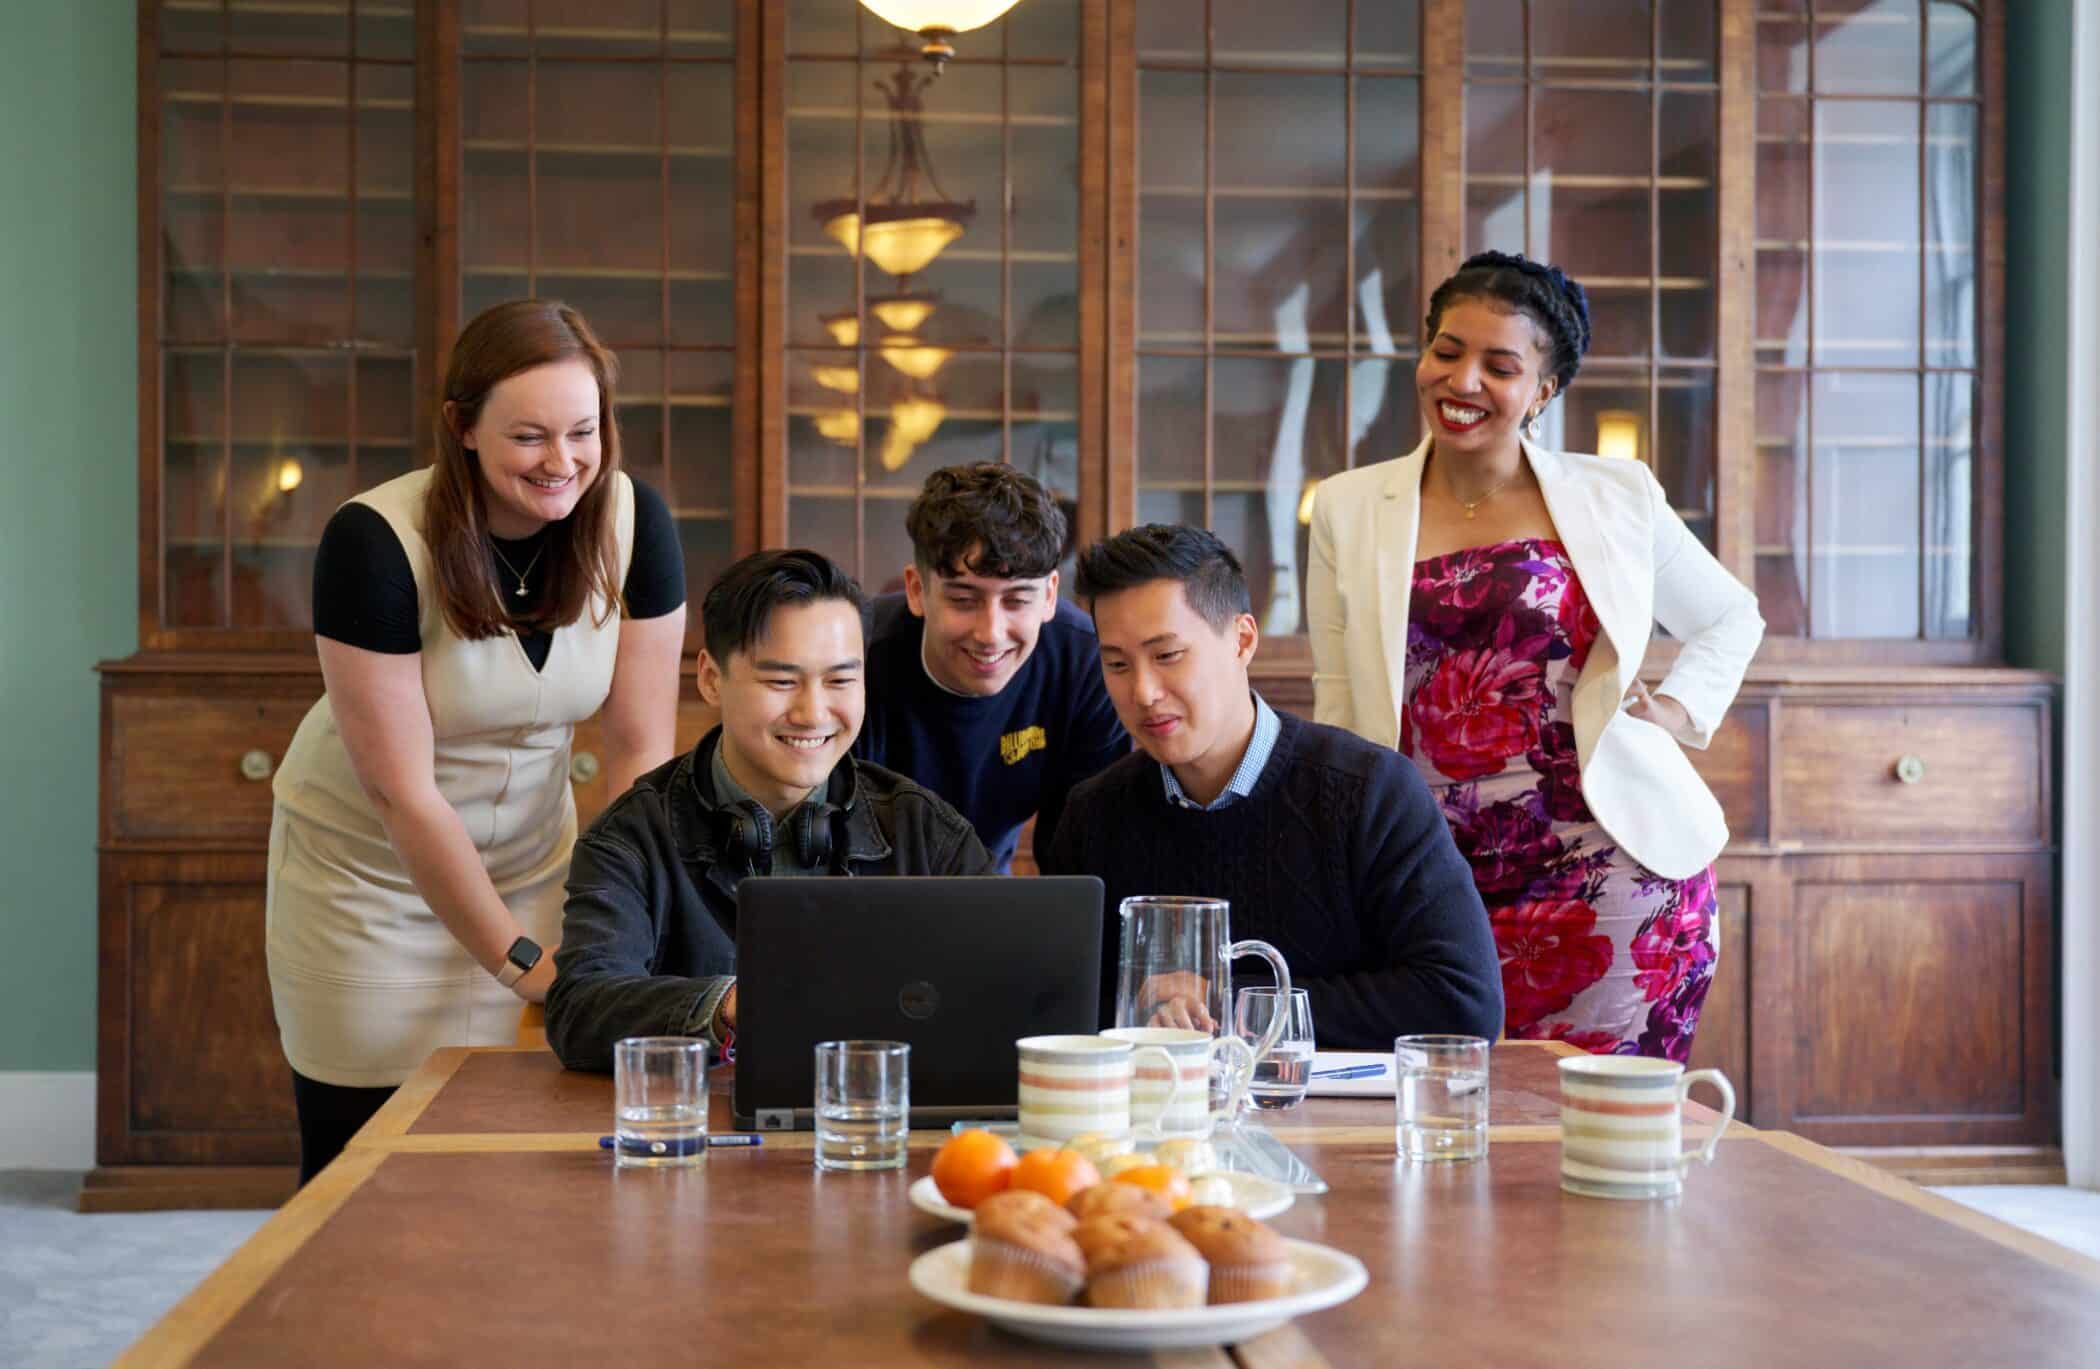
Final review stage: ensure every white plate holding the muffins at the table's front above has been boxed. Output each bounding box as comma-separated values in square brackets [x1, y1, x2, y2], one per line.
[911, 1241, 1369, 1350]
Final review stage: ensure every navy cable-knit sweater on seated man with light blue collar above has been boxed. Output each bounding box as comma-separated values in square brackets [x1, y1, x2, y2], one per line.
[1042, 714, 1502, 1050]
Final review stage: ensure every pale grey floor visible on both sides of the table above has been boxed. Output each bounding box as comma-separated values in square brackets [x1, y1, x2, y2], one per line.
[0, 1170, 2100, 1369]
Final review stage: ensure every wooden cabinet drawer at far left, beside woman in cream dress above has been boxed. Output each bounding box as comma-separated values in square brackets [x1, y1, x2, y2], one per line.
[103, 693, 313, 848]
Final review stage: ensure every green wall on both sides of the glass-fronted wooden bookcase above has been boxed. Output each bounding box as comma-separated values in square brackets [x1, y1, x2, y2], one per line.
[0, 0, 2071, 1071]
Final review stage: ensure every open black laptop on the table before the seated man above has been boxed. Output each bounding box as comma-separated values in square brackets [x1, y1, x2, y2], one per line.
[735, 876, 1103, 1132]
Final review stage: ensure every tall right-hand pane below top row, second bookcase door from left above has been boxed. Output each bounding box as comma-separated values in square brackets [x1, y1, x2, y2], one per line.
[666, 63, 737, 346]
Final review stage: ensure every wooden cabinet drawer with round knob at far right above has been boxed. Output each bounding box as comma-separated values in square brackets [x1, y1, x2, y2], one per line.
[1779, 701, 2050, 846]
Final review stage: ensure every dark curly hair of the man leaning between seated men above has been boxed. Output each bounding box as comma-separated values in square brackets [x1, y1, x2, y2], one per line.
[905, 462, 1067, 580]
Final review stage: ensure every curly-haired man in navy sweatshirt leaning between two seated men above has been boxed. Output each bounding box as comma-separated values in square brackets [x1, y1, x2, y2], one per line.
[853, 462, 1130, 871]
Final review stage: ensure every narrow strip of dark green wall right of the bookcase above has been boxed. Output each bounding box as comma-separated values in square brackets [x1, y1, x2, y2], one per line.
[2006, 0, 2074, 672]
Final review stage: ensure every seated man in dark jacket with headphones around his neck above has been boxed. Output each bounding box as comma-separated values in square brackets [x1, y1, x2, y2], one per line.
[546, 550, 991, 1071]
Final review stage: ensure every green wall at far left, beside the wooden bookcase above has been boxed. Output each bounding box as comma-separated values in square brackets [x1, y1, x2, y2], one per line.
[0, 0, 139, 1071]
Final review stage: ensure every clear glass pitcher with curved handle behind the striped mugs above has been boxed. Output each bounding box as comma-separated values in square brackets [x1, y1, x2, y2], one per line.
[1115, 897, 1292, 1119]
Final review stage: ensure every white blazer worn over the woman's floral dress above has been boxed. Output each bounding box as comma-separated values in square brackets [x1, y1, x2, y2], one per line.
[1306, 439, 1764, 880]
